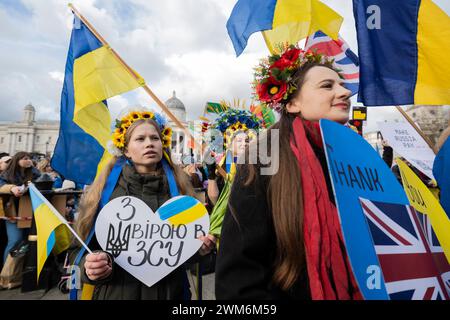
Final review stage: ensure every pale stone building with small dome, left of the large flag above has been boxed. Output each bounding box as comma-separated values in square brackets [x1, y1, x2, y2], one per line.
[0, 103, 59, 155]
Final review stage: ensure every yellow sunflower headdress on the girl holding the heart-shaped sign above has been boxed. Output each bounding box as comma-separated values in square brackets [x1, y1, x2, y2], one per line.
[109, 108, 172, 156]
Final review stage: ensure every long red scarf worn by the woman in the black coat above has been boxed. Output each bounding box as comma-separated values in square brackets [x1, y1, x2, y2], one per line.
[291, 118, 361, 300]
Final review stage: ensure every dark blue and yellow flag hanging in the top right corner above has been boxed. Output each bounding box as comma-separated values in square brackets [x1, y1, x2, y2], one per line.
[353, 0, 450, 106]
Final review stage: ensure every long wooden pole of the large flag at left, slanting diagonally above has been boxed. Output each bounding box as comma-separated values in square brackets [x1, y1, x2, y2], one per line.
[69, 3, 226, 177]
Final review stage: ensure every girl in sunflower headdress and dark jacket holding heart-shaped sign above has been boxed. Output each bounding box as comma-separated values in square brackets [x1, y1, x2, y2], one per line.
[77, 110, 214, 300]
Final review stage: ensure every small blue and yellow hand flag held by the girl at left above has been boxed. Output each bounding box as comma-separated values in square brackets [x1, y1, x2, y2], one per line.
[29, 184, 70, 280]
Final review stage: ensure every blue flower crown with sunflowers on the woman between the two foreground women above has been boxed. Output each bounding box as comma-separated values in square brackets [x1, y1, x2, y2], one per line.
[211, 109, 261, 148]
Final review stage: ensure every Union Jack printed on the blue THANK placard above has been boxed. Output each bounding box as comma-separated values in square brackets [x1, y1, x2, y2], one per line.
[360, 198, 450, 300]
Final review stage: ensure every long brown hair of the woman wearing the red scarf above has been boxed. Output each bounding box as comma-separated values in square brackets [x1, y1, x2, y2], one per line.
[239, 62, 337, 290]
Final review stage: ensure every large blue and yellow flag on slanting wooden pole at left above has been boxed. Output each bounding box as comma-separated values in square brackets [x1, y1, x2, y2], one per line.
[51, 16, 145, 184]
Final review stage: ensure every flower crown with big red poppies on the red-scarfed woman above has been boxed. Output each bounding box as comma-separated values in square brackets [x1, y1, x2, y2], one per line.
[252, 45, 333, 112]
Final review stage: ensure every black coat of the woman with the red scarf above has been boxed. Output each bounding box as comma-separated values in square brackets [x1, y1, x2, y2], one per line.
[216, 166, 310, 300]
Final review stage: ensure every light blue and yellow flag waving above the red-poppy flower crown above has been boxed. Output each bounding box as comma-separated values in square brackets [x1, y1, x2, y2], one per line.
[227, 0, 343, 56]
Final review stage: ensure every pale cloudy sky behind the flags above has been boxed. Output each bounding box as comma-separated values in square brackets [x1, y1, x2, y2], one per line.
[0, 0, 450, 131]
